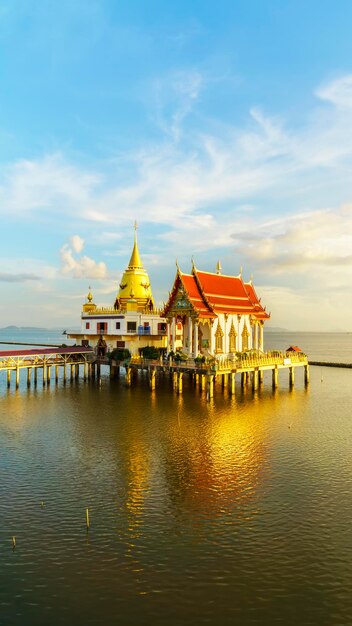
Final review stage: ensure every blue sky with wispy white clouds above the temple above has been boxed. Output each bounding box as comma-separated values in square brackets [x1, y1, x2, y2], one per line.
[0, 0, 352, 331]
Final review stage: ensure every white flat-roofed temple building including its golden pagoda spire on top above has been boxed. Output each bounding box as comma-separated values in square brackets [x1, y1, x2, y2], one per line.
[67, 224, 167, 356]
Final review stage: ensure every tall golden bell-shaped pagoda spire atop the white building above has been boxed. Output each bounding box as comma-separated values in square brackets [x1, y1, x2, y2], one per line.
[115, 223, 154, 313]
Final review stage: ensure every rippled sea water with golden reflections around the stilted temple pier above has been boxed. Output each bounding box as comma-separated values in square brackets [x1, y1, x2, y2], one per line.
[0, 333, 352, 626]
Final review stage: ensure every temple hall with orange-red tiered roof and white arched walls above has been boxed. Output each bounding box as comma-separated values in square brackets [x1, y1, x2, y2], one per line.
[163, 262, 270, 357]
